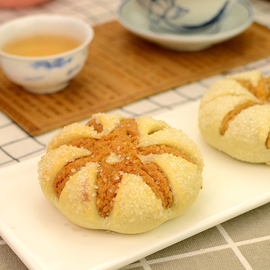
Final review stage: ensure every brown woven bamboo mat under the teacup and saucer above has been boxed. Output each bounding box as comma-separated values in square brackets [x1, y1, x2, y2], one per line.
[0, 21, 270, 135]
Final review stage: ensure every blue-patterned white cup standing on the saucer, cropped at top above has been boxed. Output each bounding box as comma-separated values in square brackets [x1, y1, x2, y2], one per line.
[134, 0, 237, 32]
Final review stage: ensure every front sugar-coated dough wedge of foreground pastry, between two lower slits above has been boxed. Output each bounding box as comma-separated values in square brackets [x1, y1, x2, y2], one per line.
[108, 174, 165, 234]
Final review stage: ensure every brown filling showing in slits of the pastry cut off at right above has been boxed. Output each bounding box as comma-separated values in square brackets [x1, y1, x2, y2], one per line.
[220, 77, 270, 149]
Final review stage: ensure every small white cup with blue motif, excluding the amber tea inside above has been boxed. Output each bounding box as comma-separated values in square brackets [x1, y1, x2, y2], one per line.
[0, 14, 94, 94]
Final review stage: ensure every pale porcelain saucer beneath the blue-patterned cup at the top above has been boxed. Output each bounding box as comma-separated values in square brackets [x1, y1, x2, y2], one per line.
[117, 0, 254, 51]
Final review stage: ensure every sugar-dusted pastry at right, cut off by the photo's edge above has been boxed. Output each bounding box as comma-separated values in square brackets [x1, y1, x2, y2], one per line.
[199, 70, 270, 165]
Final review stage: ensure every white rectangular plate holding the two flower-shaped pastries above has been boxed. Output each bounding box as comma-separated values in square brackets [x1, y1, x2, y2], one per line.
[0, 102, 270, 270]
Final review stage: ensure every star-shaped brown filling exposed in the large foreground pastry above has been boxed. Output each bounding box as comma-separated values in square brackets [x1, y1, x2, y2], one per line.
[54, 119, 191, 217]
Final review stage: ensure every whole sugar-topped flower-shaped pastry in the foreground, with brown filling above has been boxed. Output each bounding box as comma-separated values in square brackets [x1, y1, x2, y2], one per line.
[39, 114, 203, 234]
